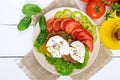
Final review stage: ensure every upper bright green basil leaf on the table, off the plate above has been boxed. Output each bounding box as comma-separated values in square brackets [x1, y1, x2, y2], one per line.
[22, 4, 41, 16]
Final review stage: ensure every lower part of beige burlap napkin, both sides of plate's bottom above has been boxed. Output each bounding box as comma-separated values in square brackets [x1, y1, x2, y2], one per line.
[18, 44, 111, 80]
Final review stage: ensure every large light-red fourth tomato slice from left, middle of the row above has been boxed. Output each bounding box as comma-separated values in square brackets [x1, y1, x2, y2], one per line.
[65, 21, 81, 34]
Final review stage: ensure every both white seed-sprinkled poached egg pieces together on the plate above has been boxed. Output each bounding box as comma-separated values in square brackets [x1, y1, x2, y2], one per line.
[46, 35, 85, 63]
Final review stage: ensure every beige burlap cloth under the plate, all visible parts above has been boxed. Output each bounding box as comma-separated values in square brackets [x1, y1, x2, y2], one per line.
[18, 0, 111, 80]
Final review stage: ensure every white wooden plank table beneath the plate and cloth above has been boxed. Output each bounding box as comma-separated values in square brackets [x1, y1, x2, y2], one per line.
[0, 0, 120, 80]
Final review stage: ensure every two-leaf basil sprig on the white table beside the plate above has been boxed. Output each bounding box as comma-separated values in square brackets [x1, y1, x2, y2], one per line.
[17, 4, 41, 31]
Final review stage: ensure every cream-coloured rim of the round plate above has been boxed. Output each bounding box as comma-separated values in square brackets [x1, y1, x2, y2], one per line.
[32, 7, 100, 75]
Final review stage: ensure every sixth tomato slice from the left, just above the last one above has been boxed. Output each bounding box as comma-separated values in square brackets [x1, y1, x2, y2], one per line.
[77, 29, 93, 41]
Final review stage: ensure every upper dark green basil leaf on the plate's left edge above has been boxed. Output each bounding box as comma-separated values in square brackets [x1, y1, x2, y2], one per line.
[39, 15, 47, 32]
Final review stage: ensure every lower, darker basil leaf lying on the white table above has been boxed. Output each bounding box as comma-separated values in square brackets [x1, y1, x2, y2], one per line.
[17, 16, 31, 31]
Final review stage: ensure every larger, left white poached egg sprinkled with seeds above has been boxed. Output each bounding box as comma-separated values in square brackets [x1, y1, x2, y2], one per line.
[46, 35, 70, 58]
